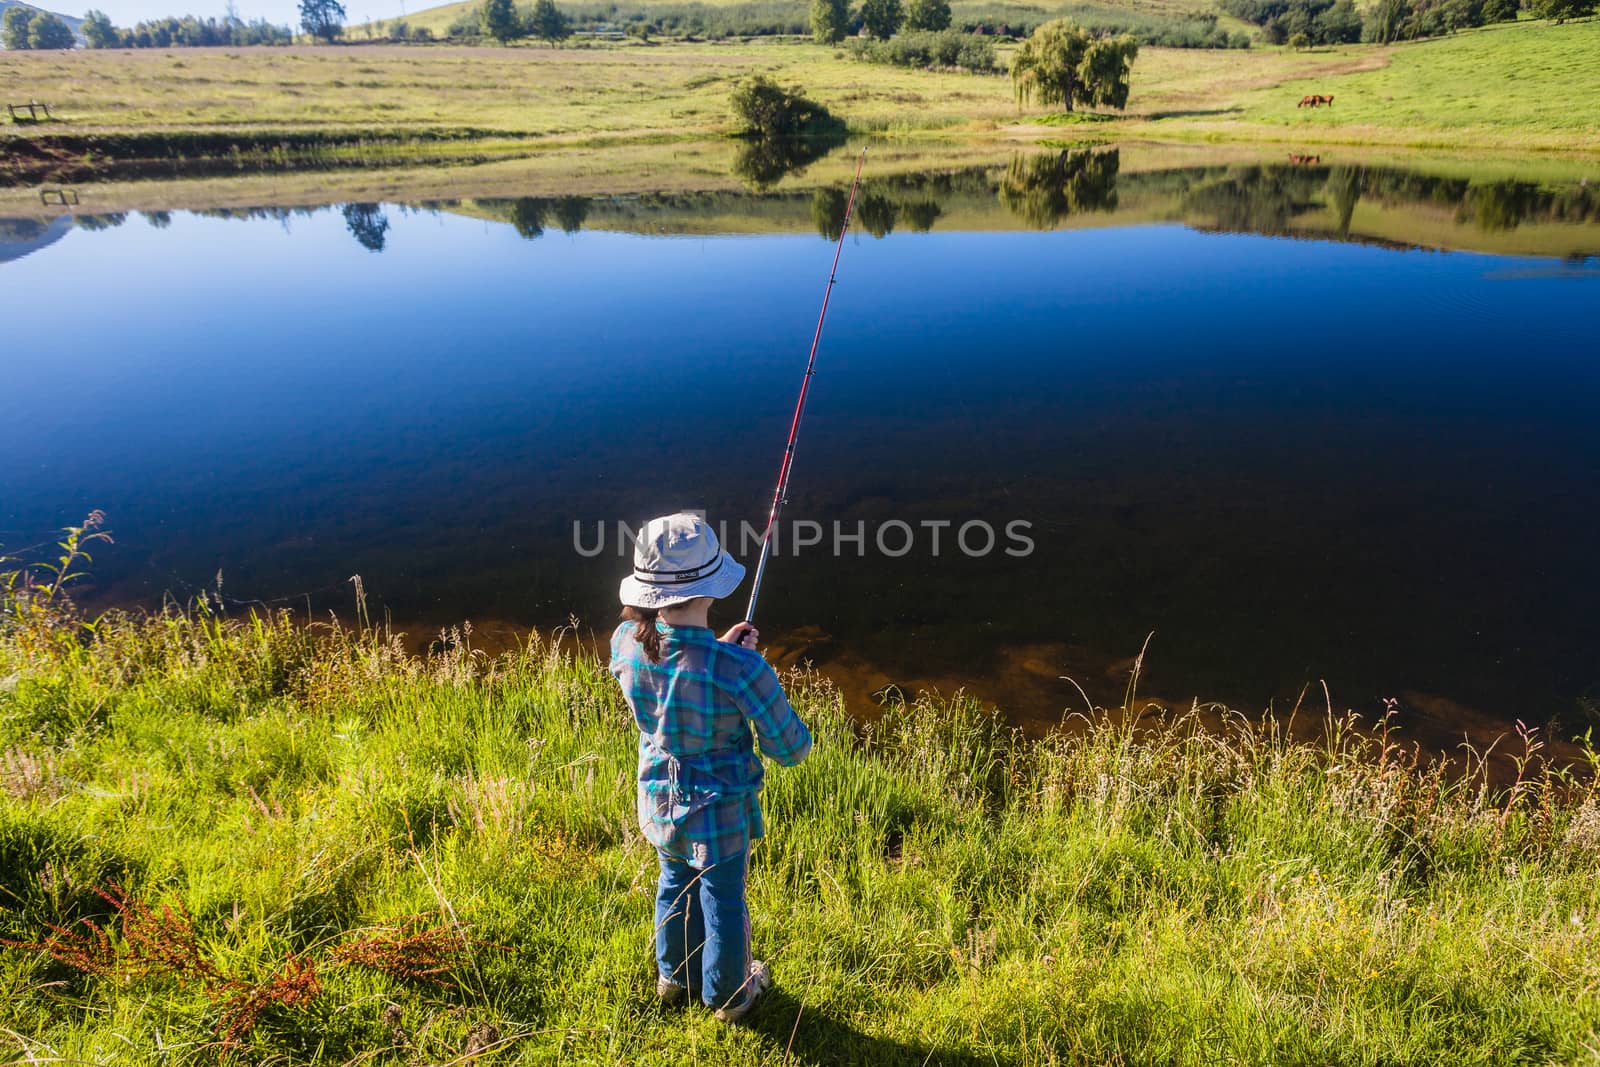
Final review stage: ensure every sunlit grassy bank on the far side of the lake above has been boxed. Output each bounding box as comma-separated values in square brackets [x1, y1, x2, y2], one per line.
[0, 21, 1600, 179]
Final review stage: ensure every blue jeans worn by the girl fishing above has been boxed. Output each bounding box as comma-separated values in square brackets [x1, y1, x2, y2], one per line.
[656, 849, 750, 1008]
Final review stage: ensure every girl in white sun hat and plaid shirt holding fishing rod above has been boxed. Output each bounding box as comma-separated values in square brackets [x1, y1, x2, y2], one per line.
[611, 514, 811, 1022]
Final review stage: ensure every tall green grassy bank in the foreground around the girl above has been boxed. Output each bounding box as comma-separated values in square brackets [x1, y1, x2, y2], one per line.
[0, 604, 1600, 1064]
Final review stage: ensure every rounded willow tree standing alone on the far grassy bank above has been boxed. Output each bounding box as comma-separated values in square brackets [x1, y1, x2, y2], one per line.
[1011, 19, 1139, 110]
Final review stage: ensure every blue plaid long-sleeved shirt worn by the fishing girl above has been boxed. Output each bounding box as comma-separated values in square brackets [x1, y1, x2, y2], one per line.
[611, 622, 811, 867]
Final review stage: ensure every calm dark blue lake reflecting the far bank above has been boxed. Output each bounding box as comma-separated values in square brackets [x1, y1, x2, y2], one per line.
[0, 149, 1600, 739]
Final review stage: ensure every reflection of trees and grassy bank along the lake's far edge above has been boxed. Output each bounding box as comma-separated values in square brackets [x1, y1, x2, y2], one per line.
[9, 159, 1600, 262]
